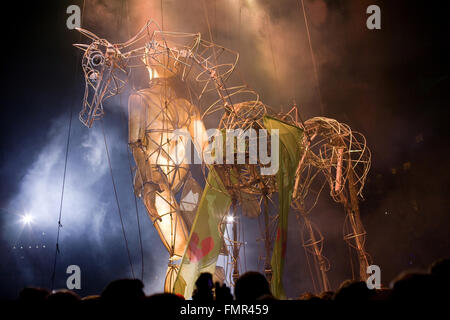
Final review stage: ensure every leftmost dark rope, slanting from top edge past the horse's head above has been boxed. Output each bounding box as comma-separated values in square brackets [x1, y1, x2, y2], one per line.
[50, 0, 86, 290]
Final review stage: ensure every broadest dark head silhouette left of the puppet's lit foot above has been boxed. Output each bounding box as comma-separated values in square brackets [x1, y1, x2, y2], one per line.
[101, 279, 145, 302]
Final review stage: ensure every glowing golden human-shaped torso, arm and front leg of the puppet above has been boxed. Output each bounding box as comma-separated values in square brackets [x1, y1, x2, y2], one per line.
[128, 70, 205, 259]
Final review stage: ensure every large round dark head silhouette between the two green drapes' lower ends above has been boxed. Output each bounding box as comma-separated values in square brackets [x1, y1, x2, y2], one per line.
[234, 271, 271, 301]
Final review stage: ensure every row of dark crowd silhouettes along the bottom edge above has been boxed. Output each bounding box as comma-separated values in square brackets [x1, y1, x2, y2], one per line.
[17, 259, 450, 305]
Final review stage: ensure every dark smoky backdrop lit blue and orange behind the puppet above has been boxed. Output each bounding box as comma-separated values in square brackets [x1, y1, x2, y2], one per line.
[0, 0, 450, 298]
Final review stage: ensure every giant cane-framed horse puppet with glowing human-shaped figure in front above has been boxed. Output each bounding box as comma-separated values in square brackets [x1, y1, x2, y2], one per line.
[75, 20, 370, 295]
